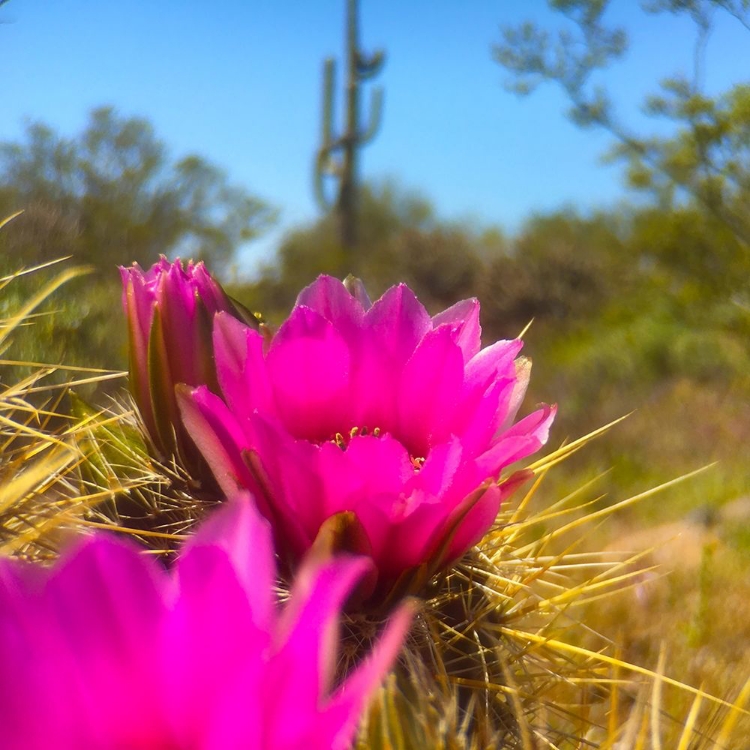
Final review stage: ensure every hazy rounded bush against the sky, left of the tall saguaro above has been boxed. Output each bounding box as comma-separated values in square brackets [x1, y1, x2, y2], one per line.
[0, 107, 272, 271]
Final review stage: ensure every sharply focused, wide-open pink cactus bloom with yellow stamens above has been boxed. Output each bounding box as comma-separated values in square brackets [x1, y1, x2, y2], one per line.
[178, 276, 555, 603]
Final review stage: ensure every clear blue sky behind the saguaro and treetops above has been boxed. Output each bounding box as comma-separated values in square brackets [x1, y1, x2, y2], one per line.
[0, 0, 750, 272]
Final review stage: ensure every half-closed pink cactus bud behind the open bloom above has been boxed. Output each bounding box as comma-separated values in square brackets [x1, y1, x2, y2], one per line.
[120, 256, 254, 467]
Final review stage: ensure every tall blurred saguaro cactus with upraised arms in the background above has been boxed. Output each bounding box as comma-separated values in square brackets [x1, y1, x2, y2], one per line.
[315, 0, 385, 258]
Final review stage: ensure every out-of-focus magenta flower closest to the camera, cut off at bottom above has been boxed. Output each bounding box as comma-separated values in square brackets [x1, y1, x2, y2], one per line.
[0, 498, 411, 750]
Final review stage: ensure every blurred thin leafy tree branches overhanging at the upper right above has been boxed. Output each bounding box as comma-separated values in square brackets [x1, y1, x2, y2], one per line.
[494, 0, 750, 246]
